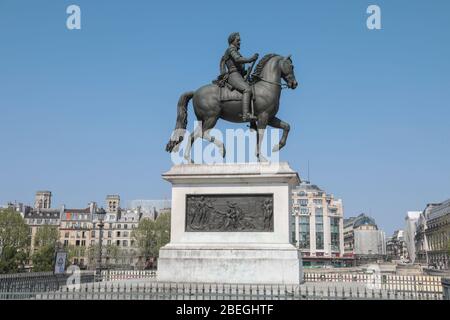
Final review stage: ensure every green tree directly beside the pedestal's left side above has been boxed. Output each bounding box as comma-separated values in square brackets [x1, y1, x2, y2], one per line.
[132, 213, 170, 266]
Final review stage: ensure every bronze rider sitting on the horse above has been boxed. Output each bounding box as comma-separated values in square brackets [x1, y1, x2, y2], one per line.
[220, 32, 258, 122]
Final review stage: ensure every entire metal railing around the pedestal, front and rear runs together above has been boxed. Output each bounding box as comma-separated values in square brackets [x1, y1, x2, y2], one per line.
[0, 270, 443, 300]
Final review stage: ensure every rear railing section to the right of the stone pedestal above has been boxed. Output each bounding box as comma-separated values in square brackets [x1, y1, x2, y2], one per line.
[305, 273, 442, 294]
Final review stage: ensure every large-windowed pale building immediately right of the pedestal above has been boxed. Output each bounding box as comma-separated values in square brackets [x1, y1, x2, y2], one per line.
[292, 181, 346, 267]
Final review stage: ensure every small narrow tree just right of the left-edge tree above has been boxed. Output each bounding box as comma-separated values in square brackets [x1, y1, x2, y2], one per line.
[31, 225, 59, 272]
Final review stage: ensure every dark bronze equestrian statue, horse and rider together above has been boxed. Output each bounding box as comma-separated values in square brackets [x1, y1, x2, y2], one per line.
[166, 32, 298, 162]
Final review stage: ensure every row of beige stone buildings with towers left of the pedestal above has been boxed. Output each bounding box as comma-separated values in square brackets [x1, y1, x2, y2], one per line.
[23, 191, 174, 269]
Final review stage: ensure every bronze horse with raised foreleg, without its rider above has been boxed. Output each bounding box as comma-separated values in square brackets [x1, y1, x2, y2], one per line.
[166, 54, 298, 162]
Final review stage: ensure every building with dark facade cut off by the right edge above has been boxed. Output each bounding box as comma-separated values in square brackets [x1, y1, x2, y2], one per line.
[425, 199, 450, 270]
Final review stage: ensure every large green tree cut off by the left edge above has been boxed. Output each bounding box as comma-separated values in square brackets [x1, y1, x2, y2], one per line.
[0, 208, 30, 273]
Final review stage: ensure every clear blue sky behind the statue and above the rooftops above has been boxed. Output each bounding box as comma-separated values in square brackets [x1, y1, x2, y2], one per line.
[0, 0, 450, 234]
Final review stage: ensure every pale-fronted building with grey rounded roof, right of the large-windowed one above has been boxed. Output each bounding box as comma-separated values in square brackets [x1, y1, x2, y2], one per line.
[344, 213, 386, 265]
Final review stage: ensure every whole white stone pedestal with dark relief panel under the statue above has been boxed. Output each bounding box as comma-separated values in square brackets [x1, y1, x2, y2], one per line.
[158, 163, 303, 284]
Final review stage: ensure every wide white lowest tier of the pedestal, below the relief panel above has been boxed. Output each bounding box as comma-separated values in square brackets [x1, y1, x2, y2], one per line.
[158, 244, 303, 285]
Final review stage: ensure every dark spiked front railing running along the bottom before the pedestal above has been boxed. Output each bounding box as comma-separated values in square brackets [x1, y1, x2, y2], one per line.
[0, 282, 442, 300]
